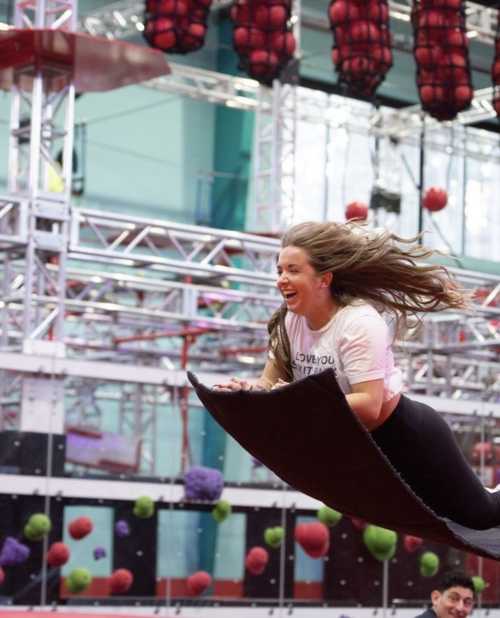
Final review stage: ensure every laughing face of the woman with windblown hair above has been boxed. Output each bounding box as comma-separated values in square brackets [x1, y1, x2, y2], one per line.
[276, 245, 331, 316]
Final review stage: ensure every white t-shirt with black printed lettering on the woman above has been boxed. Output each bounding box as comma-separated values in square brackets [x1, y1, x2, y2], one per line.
[285, 302, 403, 401]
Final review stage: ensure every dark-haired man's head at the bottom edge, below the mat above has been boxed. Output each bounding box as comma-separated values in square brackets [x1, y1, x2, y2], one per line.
[431, 572, 474, 618]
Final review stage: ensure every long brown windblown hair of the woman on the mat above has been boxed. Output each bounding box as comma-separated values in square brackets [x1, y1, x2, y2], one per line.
[268, 221, 468, 379]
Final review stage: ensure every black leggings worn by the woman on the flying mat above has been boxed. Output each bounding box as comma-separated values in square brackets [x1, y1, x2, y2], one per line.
[371, 395, 500, 530]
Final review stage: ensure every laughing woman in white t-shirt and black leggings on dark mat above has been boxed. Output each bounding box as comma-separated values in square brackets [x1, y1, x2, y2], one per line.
[215, 222, 500, 529]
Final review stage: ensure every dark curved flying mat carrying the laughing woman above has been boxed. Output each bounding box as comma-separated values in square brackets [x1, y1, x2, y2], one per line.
[188, 369, 500, 559]
